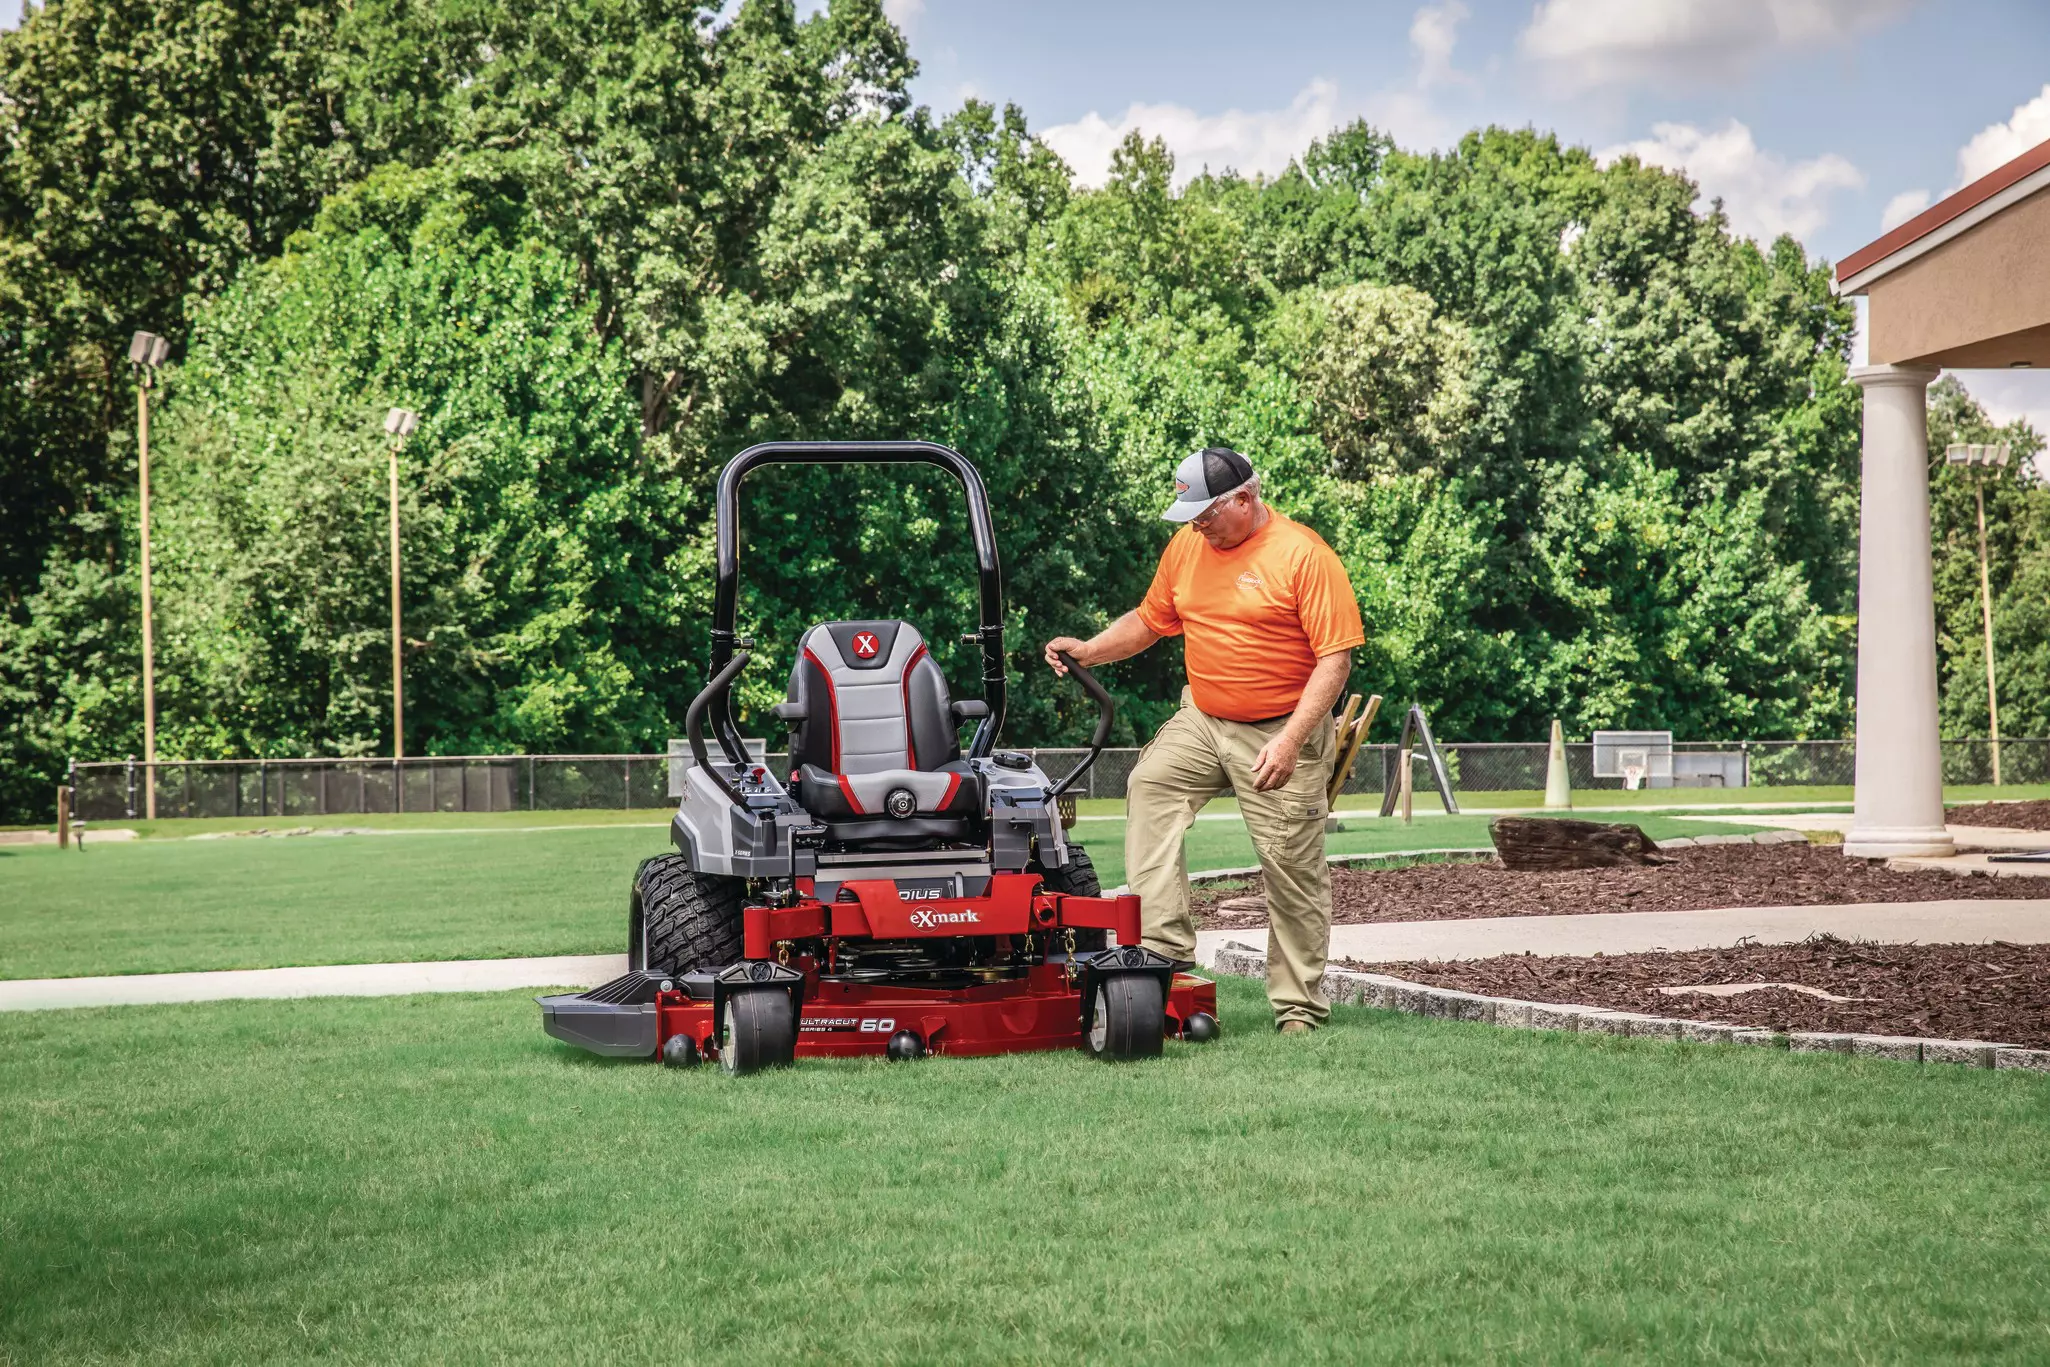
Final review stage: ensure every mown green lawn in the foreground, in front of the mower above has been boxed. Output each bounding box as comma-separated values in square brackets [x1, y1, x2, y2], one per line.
[0, 982, 2050, 1363]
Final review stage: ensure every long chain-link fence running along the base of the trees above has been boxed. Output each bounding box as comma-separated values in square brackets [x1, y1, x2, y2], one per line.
[72, 738, 2050, 822]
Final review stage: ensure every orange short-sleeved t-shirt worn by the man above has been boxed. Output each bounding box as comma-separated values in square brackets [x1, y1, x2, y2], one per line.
[1140, 508, 1367, 721]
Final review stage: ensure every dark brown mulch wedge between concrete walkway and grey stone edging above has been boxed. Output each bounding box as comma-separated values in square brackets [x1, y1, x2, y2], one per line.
[1347, 935, 2050, 1049]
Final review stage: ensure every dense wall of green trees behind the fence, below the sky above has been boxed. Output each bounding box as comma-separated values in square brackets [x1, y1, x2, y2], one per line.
[0, 0, 2050, 816]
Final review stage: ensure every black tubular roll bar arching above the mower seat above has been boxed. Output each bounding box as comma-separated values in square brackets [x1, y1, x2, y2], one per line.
[711, 441, 1005, 764]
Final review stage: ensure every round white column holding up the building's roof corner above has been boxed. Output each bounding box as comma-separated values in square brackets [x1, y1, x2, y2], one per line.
[1843, 365, 1954, 859]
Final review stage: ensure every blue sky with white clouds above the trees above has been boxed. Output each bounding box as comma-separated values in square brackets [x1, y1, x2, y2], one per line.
[886, 0, 2050, 430]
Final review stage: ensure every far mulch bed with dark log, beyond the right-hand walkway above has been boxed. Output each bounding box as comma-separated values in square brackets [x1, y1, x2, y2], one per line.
[1195, 844, 2050, 930]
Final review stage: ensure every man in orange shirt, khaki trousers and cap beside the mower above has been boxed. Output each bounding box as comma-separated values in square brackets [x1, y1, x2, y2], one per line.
[1046, 447, 1365, 1033]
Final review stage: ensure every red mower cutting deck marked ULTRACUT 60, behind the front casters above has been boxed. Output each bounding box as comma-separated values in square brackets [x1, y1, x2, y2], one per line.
[656, 959, 1218, 1058]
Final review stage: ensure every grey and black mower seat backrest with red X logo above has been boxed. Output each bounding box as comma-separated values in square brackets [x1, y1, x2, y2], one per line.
[789, 621, 961, 775]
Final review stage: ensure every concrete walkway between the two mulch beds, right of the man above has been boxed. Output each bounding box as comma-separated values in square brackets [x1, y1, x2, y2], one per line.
[1195, 898, 2050, 963]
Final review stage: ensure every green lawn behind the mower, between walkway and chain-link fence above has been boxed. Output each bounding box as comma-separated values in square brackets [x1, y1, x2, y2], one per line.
[0, 816, 1754, 978]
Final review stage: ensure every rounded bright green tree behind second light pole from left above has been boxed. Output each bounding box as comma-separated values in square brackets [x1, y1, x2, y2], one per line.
[145, 166, 666, 756]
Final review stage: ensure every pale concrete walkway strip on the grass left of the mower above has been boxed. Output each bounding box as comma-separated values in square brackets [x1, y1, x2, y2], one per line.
[0, 955, 627, 1010]
